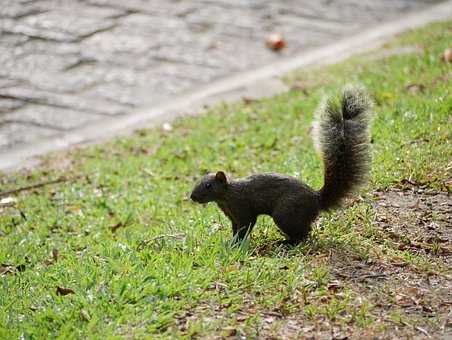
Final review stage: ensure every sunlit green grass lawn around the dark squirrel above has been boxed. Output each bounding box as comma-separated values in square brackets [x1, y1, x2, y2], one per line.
[0, 22, 452, 338]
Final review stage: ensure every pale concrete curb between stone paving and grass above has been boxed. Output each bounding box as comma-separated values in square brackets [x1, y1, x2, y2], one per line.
[0, 0, 452, 171]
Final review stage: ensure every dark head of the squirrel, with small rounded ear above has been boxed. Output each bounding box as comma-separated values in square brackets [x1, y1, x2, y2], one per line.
[190, 171, 228, 203]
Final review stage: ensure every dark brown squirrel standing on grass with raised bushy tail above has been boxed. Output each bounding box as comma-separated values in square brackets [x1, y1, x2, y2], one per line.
[190, 87, 372, 244]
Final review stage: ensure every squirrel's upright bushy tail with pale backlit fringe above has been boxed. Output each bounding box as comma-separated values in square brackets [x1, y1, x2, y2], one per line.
[313, 87, 372, 210]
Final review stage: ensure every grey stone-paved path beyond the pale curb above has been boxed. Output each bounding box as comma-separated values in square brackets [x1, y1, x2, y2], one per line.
[0, 0, 439, 159]
